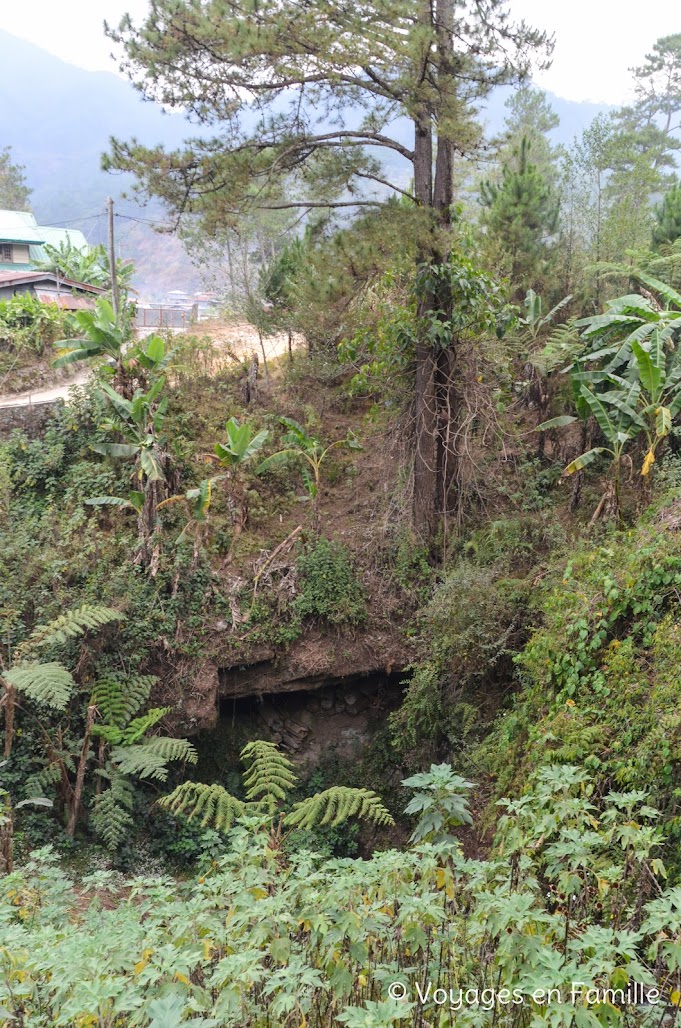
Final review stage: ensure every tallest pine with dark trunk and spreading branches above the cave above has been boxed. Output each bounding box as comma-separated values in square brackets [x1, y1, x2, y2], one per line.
[105, 0, 551, 538]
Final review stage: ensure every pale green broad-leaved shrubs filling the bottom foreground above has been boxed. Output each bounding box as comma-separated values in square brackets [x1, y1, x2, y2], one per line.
[0, 766, 681, 1028]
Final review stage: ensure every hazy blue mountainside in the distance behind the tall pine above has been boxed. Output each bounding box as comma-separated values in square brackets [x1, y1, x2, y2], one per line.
[0, 31, 606, 297]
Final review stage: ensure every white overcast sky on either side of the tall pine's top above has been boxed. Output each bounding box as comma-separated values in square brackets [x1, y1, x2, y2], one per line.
[0, 0, 681, 104]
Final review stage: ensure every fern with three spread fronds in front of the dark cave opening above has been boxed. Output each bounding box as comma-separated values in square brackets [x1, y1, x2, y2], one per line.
[158, 739, 395, 832]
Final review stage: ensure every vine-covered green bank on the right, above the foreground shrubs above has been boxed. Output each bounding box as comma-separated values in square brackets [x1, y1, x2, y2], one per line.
[473, 509, 681, 817]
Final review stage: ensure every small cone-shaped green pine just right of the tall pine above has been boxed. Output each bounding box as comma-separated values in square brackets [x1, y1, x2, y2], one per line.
[480, 138, 559, 297]
